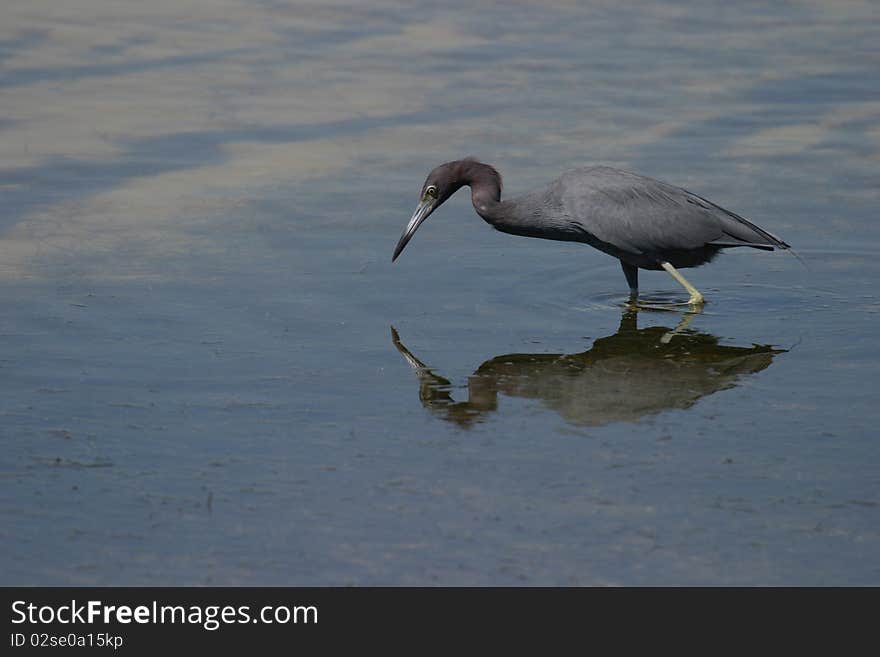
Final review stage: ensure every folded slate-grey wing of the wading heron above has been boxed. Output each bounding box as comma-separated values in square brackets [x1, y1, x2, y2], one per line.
[557, 167, 788, 254]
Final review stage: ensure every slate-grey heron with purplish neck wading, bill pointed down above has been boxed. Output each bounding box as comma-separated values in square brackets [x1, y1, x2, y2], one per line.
[391, 158, 789, 304]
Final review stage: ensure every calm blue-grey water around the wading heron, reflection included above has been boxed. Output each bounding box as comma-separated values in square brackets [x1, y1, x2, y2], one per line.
[0, 0, 880, 585]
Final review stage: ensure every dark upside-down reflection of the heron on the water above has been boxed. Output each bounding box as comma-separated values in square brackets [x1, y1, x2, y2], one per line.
[391, 309, 787, 427]
